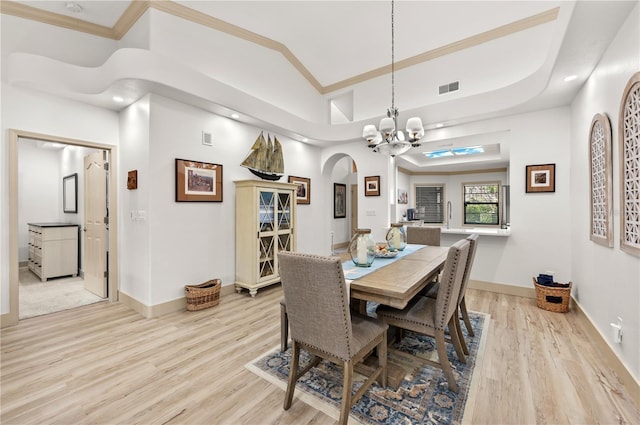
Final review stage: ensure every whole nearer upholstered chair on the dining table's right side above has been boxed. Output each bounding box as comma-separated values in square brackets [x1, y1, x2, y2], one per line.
[377, 239, 469, 392]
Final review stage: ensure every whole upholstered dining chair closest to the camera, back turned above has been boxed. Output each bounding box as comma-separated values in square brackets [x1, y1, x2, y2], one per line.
[278, 251, 388, 424]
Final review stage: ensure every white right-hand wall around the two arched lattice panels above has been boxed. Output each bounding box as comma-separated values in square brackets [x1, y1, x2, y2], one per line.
[570, 5, 640, 380]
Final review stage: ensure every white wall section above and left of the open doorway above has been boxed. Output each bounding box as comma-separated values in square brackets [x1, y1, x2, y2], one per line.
[0, 83, 119, 314]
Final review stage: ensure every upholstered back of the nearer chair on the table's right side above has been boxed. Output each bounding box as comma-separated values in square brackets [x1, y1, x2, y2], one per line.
[434, 239, 469, 330]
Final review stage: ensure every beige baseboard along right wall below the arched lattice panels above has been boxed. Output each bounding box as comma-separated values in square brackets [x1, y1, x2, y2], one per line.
[571, 297, 640, 408]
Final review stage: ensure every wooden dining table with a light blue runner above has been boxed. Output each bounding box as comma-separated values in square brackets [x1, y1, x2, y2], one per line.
[343, 244, 449, 312]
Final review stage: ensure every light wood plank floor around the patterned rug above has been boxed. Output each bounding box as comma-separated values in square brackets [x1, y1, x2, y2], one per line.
[0, 286, 640, 425]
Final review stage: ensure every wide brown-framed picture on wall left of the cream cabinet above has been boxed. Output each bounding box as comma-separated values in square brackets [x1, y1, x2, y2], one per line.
[176, 158, 222, 202]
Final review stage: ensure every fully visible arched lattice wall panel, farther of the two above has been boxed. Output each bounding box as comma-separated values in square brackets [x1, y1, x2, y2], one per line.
[589, 114, 613, 247]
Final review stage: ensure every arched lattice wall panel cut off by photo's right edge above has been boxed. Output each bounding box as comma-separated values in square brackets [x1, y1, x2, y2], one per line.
[618, 72, 640, 257]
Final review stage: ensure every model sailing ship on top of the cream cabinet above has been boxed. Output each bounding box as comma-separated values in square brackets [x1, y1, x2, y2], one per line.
[240, 132, 284, 180]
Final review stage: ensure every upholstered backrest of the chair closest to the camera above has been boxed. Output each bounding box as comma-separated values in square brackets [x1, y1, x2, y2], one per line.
[278, 251, 355, 361]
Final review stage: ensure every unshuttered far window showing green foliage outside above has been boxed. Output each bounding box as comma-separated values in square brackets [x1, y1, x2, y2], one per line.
[463, 182, 500, 225]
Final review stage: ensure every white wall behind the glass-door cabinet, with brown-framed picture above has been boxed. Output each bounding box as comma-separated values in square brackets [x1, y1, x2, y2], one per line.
[120, 95, 328, 305]
